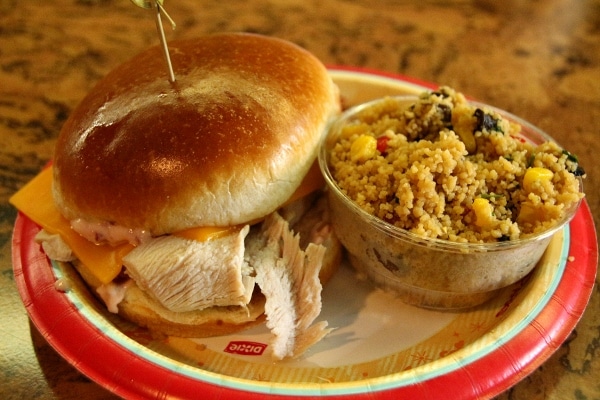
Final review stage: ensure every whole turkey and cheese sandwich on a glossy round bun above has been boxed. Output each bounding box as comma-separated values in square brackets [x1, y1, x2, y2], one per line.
[11, 33, 341, 359]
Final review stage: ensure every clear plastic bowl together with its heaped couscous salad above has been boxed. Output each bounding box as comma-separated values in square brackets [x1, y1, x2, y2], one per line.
[319, 87, 585, 309]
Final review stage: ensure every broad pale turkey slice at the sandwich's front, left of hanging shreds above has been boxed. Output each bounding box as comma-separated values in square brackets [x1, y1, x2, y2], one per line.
[123, 226, 254, 312]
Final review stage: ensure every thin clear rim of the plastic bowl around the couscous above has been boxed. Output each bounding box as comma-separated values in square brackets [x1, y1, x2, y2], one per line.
[317, 95, 583, 253]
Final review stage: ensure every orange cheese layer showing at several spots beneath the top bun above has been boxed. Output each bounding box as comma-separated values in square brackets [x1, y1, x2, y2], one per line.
[9, 163, 324, 283]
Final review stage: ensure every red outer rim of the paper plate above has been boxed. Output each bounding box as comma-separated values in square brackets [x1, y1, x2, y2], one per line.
[12, 66, 598, 400]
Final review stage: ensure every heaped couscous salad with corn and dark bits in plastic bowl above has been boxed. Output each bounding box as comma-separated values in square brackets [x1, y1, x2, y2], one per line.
[329, 87, 585, 243]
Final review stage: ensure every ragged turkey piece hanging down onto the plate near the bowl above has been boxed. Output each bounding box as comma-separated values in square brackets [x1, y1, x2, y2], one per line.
[246, 213, 331, 359]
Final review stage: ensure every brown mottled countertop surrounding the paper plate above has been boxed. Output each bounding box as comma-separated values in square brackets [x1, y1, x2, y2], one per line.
[0, 0, 600, 400]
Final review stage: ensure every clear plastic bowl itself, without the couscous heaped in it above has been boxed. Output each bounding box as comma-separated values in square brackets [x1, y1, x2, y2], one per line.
[319, 96, 582, 310]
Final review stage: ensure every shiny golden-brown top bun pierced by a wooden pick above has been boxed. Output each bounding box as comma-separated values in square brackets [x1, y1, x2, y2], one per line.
[53, 34, 339, 235]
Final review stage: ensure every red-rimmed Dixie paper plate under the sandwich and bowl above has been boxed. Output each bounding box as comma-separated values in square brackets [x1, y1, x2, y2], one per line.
[13, 68, 598, 399]
